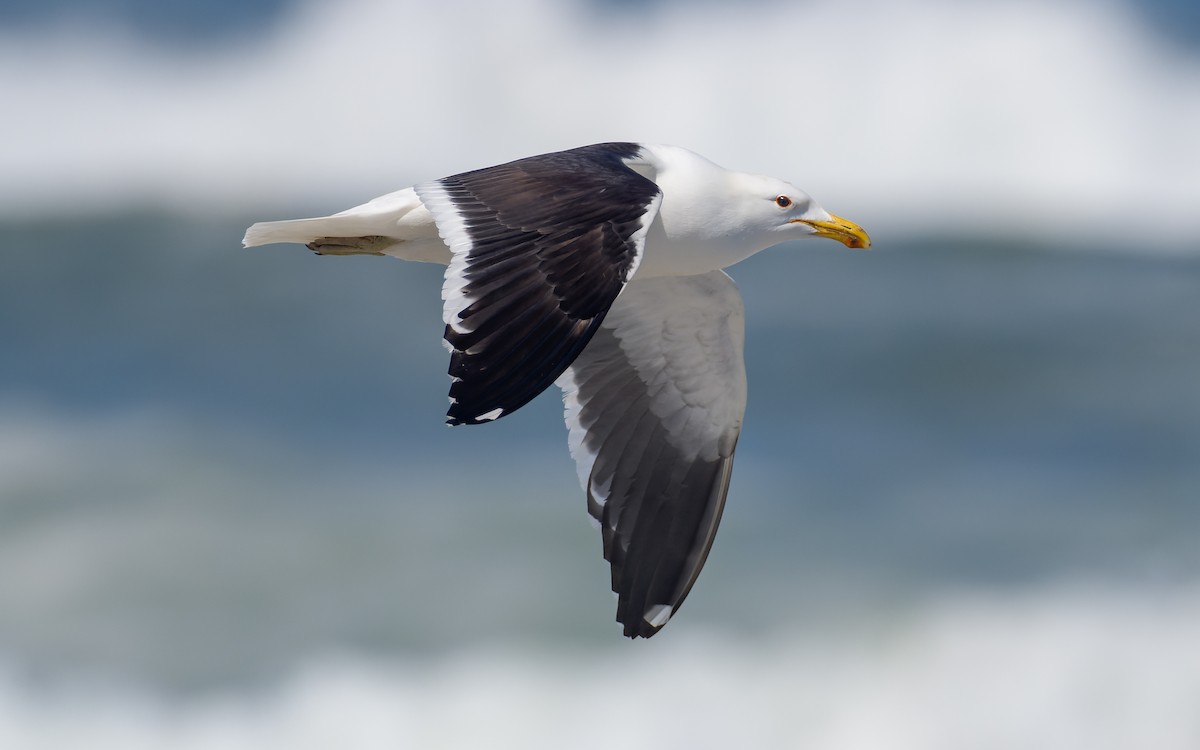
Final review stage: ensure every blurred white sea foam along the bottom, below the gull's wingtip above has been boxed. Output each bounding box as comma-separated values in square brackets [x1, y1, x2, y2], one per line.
[0, 590, 1200, 750]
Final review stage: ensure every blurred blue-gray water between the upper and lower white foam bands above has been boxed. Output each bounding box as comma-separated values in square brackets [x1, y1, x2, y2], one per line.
[0, 215, 1200, 746]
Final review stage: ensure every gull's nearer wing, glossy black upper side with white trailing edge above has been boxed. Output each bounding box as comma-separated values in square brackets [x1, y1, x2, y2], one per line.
[415, 143, 661, 425]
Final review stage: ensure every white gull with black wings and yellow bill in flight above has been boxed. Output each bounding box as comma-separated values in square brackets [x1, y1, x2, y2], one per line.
[242, 143, 871, 638]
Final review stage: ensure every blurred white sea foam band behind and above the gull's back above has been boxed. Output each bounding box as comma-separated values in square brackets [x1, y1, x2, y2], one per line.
[0, 0, 1200, 246]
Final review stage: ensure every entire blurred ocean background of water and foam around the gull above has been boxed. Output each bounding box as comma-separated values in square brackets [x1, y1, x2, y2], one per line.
[0, 0, 1200, 750]
